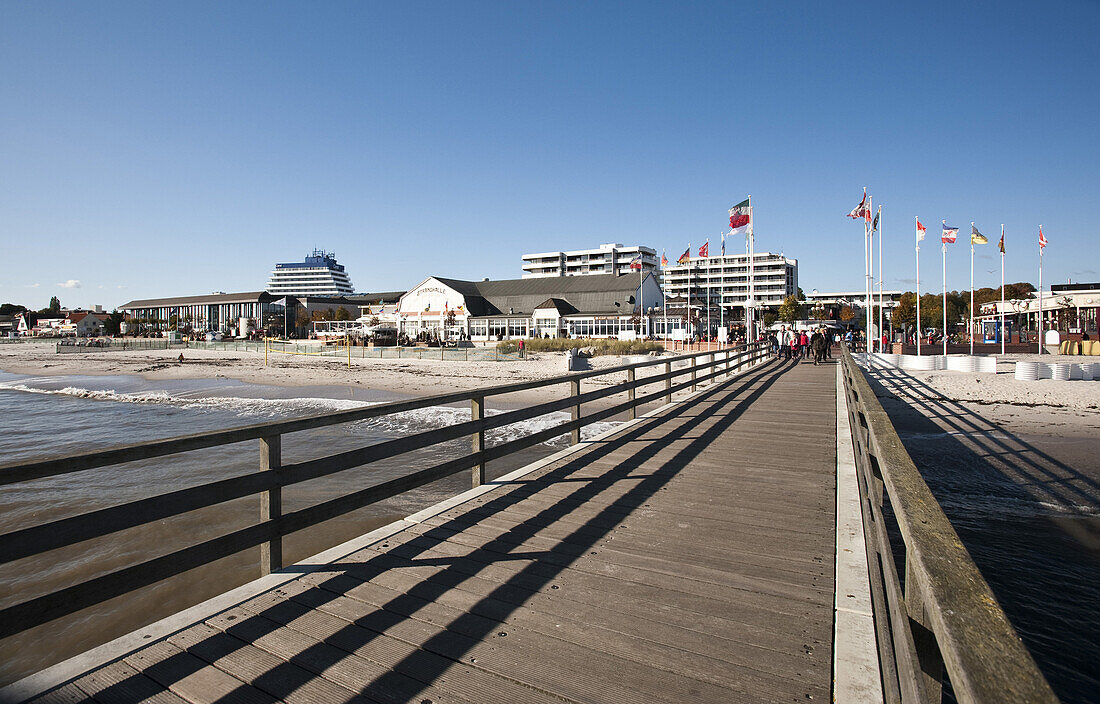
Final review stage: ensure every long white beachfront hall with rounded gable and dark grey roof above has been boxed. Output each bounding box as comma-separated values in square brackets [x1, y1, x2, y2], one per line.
[394, 272, 662, 341]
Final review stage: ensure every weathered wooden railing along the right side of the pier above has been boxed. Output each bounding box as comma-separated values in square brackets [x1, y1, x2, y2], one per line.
[840, 347, 1058, 704]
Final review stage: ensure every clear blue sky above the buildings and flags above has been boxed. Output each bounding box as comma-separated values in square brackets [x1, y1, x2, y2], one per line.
[0, 1, 1100, 308]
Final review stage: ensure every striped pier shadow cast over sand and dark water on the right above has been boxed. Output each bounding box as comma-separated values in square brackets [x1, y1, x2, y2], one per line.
[867, 367, 1100, 702]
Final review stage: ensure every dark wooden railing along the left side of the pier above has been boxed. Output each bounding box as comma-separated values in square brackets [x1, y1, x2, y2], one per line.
[0, 343, 769, 638]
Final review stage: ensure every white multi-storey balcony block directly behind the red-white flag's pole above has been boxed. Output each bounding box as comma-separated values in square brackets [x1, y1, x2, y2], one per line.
[661, 252, 799, 322]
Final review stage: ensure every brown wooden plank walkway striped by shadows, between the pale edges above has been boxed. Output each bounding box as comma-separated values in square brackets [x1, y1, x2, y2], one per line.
[27, 363, 836, 704]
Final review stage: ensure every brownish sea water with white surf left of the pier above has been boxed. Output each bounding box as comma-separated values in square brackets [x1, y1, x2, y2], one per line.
[0, 372, 616, 685]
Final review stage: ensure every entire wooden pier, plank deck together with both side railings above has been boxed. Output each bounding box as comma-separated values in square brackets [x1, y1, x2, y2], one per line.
[0, 347, 1054, 704]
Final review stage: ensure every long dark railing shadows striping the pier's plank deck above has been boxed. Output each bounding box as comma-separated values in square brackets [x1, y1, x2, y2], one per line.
[81, 364, 791, 702]
